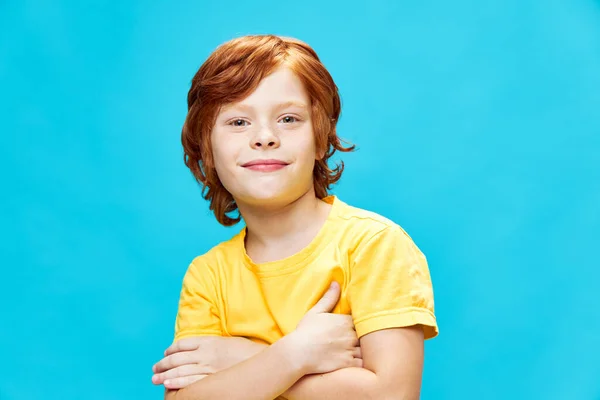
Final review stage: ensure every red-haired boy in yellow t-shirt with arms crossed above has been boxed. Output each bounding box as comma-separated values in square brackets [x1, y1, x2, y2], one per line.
[153, 35, 438, 400]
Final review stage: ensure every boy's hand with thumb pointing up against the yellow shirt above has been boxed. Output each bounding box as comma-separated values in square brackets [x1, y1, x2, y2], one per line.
[288, 282, 362, 374]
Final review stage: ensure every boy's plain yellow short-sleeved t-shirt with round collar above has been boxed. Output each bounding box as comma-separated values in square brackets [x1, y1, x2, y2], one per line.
[175, 196, 438, 344]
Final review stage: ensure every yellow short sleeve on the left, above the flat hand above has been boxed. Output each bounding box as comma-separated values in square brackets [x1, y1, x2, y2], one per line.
[175, 260, 222, 340]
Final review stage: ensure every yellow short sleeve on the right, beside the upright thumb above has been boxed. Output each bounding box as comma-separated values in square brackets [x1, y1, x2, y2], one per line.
[348, 226, 438, 339]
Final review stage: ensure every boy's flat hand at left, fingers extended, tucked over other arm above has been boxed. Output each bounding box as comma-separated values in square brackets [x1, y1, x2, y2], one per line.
[152, 336, 264, 389]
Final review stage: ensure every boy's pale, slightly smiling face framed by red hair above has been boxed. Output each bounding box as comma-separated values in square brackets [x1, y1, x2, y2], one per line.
[211, 67, 316, 206]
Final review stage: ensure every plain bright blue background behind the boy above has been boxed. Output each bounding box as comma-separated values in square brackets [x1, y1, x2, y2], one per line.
[0, 0, 600, 400]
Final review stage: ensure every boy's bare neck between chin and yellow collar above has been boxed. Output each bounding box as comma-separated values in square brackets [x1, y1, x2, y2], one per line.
[240, 188, 331, 263]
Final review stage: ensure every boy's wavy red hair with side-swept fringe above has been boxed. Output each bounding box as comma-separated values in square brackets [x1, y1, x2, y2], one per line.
[181, 35, 354, 226]
